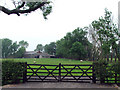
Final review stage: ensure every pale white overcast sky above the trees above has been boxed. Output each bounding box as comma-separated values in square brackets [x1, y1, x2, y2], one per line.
[0, 0, 119, 51]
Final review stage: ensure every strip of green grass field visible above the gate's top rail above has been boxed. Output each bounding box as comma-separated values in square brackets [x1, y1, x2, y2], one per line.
[3, 58, 92, 65]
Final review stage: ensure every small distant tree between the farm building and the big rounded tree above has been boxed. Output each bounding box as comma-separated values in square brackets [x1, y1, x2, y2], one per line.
[44, 42, 56, 55]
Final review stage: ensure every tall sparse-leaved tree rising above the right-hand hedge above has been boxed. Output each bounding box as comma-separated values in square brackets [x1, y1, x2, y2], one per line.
[91, 9, 120, 60]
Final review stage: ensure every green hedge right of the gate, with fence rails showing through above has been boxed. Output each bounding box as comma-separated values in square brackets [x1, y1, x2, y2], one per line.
[93, 60, 120, 83]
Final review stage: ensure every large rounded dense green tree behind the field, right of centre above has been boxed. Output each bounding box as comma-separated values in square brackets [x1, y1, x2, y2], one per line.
[56, 28, 91, 59]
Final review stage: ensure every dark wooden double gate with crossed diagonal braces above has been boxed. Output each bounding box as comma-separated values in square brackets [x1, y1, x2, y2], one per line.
[24, 63, 96, 83]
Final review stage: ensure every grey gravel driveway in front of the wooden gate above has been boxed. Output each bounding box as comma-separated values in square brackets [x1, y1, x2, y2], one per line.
[2, 82, 114, 88]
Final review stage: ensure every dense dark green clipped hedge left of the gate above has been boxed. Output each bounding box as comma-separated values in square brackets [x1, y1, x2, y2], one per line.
[2, 60, 25, 85]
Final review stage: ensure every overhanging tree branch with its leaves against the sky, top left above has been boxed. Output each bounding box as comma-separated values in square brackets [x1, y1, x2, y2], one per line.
[0, 0, 52, 19]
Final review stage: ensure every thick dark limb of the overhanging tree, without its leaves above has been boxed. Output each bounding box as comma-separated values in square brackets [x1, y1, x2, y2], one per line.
[0, 2, 49, 16]
